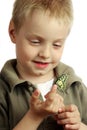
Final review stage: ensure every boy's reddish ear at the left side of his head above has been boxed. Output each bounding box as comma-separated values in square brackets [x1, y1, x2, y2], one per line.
[8, 20, 16, 43]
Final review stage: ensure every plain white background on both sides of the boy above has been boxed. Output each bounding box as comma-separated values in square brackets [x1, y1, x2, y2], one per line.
[0, 0, 87, 86]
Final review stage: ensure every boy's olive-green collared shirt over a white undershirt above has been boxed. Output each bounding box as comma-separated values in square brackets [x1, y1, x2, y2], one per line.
[0, 59, 87, 130]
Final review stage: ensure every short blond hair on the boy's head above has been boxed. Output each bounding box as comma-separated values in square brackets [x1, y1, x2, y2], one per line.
[12, 0, 73, 30]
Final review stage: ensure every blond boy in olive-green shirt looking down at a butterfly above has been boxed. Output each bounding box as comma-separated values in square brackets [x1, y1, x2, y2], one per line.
[0, 0, 87, 130]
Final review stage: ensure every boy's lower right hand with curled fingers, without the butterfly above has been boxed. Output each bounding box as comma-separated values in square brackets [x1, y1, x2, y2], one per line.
[57, 105, 81, 130]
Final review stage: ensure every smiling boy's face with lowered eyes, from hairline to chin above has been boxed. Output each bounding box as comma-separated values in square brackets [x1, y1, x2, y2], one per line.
[9, 11, 69, 79]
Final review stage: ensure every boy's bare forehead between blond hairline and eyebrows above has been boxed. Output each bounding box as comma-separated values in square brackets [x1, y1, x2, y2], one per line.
[19, 10, 69, 37]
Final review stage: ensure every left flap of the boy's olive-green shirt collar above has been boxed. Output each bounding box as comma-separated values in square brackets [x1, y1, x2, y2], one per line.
[1, 59, 25, 89]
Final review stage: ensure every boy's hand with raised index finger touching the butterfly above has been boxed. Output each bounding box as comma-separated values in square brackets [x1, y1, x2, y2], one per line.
[30, 85, 63, 119]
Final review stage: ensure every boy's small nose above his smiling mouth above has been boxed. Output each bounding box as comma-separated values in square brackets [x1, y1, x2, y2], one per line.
[39, 45, 51, 59]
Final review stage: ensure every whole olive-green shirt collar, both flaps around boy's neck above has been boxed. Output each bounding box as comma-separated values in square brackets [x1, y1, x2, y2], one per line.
[1, 59, 81, 89]
